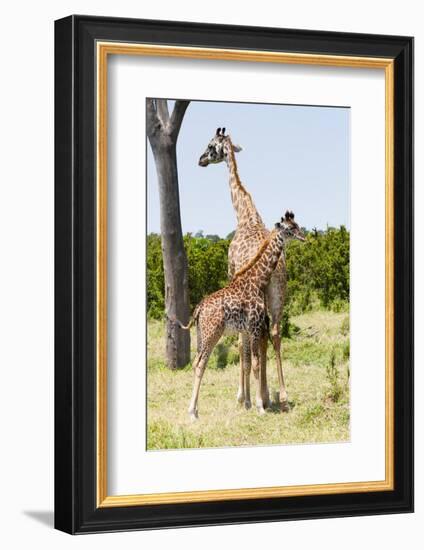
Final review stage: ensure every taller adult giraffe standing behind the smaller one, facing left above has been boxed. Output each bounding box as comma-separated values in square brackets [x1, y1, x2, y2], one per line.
[199, 128, 289, 411]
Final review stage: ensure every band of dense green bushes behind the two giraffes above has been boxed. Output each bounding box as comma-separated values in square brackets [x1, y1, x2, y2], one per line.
[147, 226, 350, 322]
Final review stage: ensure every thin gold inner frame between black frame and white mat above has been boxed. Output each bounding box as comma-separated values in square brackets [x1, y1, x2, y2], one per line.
[96, 41, 394, 507]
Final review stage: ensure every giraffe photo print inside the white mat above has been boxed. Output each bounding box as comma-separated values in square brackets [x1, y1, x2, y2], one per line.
[146, 98, 351, 451]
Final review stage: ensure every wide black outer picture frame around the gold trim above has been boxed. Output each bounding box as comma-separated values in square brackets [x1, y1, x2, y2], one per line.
[55, 15, 414, 534]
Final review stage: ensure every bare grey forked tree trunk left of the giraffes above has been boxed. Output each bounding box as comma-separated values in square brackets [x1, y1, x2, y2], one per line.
[147, 100, 190, 369]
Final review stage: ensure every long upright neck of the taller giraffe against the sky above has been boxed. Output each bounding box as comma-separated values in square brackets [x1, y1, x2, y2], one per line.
[224, 142, 264, 231]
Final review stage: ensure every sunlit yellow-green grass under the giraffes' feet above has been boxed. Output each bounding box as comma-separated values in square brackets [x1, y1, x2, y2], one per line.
[147, 311, 349, 450]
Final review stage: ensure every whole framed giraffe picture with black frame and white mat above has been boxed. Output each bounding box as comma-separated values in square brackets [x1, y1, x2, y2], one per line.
[55, 16, 413, 534]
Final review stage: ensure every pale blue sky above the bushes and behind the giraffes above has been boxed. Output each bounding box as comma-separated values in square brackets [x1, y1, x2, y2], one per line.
[147, 101, 350, 236]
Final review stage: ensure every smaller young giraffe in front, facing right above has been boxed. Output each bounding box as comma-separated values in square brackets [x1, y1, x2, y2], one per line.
[176, 212, 305, 420]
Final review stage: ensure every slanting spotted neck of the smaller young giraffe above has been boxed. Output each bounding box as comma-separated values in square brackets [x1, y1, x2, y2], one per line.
[235, 229, 284, 288]
